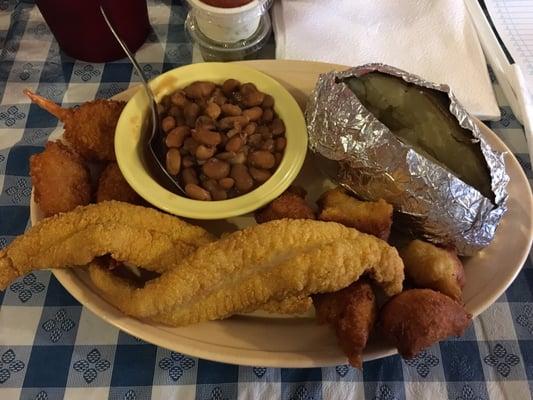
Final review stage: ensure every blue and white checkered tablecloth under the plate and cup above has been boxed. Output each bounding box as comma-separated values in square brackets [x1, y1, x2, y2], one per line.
[0, 0, 533, 400]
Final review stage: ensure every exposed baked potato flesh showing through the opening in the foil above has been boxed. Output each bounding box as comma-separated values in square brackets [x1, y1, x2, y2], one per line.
[345, 72, 494, 199]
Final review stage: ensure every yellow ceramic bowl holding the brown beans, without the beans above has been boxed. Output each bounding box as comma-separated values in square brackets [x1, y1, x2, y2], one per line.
[115, 63, 307, 219]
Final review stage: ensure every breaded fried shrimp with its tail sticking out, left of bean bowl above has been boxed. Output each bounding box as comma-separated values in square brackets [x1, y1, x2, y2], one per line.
[24, 89, 126, 161]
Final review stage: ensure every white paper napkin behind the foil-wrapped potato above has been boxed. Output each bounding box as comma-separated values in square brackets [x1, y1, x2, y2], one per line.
[273, 0, 500, 119]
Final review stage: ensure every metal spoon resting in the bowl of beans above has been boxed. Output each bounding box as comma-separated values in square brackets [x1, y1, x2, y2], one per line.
[100, 6, 185, 195]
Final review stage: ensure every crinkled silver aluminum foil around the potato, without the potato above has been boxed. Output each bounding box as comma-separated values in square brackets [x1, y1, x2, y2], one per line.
[305, 64, 509, 255]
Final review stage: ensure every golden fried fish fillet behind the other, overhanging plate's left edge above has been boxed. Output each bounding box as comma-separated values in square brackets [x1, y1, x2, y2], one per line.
[0, 201, 214, 290]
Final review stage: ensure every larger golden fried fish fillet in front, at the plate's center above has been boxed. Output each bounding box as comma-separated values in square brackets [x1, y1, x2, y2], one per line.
[85, 219, 403, 326]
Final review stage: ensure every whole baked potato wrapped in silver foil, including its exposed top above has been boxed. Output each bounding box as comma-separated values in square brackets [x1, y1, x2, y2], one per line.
[306, 64, 509, 255]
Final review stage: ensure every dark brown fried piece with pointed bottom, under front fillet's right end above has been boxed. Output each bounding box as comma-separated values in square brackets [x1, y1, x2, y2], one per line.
[312, 280, 377, 368]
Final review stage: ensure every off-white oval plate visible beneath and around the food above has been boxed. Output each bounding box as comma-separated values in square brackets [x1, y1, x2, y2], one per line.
[30, 61, 533, 367]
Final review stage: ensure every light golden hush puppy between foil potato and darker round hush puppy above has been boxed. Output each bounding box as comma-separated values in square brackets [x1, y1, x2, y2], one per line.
[400, 240, 465, 302]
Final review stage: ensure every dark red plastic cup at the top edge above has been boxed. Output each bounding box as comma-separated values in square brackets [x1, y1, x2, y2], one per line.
[36, 0, 150, 62]
